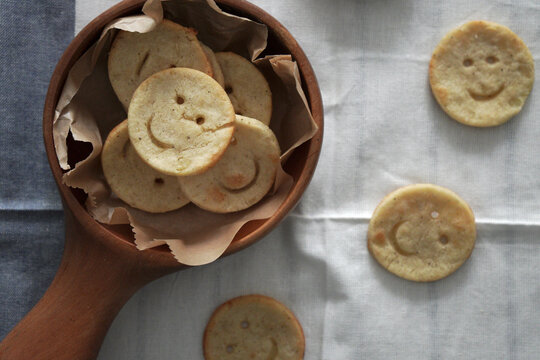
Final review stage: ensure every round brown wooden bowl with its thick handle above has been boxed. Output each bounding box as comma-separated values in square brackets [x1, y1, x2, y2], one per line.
[0, 0, 323, 360]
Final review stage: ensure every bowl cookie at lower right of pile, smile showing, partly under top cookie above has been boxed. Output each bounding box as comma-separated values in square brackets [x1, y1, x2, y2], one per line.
[179, 115, 280, 213]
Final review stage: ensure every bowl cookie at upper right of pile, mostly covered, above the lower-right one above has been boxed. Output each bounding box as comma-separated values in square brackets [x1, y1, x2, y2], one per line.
[216, 52, 272, 125]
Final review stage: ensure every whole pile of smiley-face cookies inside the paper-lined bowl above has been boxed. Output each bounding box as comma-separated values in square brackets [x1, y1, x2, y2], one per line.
[101, 20, 280, 213]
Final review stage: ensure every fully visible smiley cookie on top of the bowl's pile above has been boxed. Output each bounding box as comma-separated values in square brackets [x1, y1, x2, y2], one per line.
[128, 68, 235, 176]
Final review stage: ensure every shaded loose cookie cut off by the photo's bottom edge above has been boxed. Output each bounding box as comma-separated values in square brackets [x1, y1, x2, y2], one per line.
[203, 295, 305, 360]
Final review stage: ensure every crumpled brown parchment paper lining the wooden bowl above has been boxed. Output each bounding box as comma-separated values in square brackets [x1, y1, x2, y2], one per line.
[53, 0, 317, 265]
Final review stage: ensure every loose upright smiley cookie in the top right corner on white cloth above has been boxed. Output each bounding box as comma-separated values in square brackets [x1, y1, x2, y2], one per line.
[429, 21, 534, 127]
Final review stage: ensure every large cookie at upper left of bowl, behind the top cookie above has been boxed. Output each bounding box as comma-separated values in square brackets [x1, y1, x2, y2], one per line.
[108, 20, 212, 110]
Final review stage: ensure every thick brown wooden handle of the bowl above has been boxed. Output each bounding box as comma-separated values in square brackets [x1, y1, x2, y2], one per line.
[0, 211, 170, 360]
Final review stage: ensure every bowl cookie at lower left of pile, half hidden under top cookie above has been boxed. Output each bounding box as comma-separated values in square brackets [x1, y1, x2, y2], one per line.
[101, 121, 189, 213]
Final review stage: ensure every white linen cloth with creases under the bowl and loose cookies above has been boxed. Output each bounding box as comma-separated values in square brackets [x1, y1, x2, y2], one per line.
[71, 0, 540, 360]
